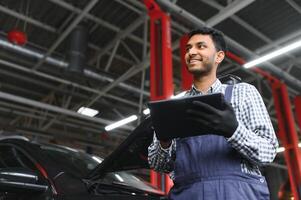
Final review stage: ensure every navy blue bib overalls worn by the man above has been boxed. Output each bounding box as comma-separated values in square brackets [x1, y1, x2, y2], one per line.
[169, 85, 270, 200]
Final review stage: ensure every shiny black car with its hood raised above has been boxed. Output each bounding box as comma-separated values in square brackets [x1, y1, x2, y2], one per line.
[0, 118, 165, 200]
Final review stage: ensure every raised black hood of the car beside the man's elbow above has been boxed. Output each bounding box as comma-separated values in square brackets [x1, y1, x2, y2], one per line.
[87, 117, 153, 180]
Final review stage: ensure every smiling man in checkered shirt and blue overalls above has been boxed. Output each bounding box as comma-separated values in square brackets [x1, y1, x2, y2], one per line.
[148, 27, 278, 200]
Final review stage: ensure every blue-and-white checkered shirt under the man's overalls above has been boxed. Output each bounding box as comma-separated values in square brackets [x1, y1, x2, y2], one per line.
[148, 79, 278, 179]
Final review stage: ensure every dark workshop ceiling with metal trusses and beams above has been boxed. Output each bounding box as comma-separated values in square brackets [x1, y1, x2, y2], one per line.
[0, 0, 301, 155]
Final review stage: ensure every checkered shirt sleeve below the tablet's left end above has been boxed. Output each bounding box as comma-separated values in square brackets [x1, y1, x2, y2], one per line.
[148, 134, 176, 173]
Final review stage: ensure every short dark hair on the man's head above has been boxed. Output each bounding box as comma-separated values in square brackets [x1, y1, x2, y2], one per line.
[188, 27, 227, 52]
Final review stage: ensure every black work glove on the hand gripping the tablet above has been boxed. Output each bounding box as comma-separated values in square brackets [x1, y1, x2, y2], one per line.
[187, 101, 238, 138]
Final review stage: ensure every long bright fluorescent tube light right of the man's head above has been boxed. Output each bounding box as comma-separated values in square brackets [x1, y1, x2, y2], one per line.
[243, 40, 301, 68]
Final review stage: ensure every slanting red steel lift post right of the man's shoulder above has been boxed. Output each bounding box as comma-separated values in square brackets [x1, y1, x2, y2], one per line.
[226, 52, 301, 200]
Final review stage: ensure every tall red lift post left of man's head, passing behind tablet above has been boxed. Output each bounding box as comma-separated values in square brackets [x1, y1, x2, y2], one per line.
[144, 0, 173, 194]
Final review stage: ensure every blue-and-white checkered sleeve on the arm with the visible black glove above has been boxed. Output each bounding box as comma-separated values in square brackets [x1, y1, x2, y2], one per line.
[227, 84, 278, 165]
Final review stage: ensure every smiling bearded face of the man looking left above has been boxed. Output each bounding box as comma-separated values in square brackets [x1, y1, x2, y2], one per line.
[185, 34, 224, 75]
